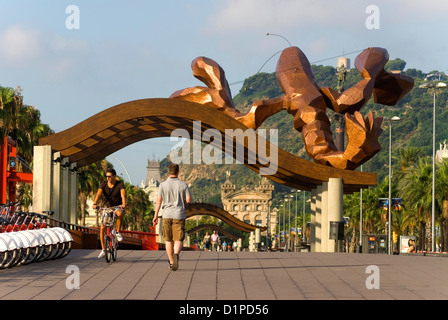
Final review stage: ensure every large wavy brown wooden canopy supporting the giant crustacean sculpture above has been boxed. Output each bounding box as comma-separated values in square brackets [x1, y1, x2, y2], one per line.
[39, 98, 377, 193]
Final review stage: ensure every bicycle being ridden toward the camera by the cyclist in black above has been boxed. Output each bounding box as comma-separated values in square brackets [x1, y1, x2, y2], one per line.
[96, 206, 123, 263]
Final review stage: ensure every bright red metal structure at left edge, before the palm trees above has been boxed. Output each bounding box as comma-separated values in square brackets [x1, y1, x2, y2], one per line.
[0, 137, 33, 203]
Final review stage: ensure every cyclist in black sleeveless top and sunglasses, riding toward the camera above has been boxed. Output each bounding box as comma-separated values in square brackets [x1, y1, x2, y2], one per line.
[92, 169, 126, 258]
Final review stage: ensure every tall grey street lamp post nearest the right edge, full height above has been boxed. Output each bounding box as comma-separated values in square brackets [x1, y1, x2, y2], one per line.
[419, 82, 447, 251]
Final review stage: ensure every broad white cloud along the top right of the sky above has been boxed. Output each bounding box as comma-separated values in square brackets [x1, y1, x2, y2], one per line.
[206, 0, 448, 34]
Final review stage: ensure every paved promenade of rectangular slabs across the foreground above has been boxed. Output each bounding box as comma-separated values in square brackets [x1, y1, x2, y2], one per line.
[0, 250, 448, 303]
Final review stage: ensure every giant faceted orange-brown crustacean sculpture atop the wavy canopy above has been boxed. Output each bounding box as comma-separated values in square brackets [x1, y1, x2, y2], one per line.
[170, 47, 414, 170]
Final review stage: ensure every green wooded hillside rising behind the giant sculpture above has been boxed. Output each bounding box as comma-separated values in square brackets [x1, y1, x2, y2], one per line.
[161, 59, 448, 210]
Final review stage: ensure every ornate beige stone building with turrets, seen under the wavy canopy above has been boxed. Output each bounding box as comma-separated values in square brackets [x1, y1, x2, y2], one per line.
[221, 172, 277, 234]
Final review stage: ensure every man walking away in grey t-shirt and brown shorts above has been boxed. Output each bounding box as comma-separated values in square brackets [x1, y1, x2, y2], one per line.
[152, 163, 191, 271]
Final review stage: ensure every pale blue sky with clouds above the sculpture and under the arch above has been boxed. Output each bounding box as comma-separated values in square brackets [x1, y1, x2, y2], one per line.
[0, 0, 448, 184]
